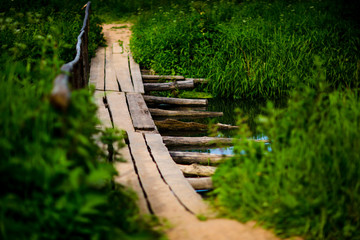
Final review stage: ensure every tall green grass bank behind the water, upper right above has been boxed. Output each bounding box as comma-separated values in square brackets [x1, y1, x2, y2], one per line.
[131, 0, 360, 99]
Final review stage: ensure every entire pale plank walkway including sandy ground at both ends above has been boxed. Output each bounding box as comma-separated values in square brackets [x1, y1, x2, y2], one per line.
[90, 24, 286, 240]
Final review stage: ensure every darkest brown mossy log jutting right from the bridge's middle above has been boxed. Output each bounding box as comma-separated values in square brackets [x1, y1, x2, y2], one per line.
[155, 119, 238, 132]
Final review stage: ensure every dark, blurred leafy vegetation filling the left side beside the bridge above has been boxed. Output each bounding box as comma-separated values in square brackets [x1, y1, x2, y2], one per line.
[0, 1, 160, 239]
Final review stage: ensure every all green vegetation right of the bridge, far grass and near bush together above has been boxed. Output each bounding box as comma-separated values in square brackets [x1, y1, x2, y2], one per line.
[131, 0, 360, 239]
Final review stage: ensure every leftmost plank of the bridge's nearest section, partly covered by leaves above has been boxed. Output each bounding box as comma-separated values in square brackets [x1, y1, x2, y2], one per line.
[114, 145, 150, 214]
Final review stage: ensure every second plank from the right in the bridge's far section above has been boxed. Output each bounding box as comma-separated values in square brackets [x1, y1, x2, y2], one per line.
[112, 53, 134, 92]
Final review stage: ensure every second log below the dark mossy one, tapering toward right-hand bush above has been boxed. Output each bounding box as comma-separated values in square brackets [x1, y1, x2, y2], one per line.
[169, 151, 232, 164]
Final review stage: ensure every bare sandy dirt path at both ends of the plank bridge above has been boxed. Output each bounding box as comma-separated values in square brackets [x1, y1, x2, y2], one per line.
[103, 23, 295, 240]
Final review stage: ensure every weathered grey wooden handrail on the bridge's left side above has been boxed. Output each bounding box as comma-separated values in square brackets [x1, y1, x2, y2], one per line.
[50, 2, 91, 110]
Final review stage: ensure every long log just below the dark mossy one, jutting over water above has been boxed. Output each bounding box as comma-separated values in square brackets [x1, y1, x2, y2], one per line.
[163, 136, 233, 146]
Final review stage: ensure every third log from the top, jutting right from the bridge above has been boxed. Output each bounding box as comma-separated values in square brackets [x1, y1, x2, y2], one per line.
[144, 95, 208, 106]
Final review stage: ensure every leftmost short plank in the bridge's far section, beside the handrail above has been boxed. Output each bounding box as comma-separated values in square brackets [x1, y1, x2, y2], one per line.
[89, 47, 105, 90]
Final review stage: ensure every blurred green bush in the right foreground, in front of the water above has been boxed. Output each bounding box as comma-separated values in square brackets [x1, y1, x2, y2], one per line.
[213, 59, 360, 239]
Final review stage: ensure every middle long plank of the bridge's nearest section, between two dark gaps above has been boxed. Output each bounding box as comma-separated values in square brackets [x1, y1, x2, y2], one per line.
[128, 132, 190, 218]
